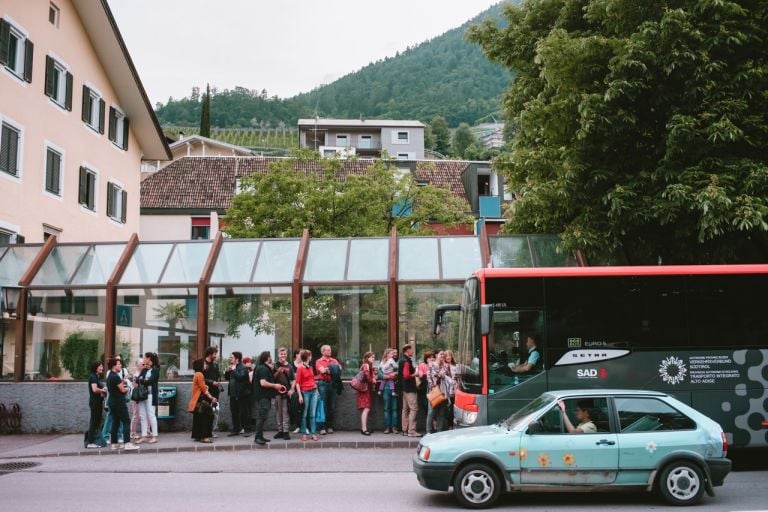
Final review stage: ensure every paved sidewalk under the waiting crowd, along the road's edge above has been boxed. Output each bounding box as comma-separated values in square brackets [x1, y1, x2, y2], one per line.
[0, 431, 419, 459]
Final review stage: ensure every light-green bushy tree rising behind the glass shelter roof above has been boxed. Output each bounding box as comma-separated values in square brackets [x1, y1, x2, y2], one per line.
[225, 151, 472, 238]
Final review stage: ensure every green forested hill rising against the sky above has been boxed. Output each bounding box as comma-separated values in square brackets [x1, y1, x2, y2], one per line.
[157, 5, 510, 128]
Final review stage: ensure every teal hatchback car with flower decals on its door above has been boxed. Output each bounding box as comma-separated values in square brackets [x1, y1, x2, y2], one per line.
[413, 390, 731, 508]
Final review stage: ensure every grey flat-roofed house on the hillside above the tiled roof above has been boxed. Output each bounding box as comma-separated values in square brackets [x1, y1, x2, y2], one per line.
[299, 118, 424, 160]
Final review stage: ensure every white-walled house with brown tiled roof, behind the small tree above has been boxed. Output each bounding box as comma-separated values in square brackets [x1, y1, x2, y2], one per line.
[139, 157, 504, 241]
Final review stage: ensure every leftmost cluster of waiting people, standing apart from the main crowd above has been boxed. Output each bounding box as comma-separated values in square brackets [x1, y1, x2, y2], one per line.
[85, 352, 160, 450]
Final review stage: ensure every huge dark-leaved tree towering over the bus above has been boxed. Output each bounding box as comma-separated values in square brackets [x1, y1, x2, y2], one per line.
[468, 0, 768, 264]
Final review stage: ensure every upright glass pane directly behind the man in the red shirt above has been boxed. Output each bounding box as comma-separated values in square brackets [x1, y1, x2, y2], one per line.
[301, 286, 387, 377]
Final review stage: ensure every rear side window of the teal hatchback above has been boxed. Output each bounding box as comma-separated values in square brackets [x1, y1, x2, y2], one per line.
[616, 398, 696, 433]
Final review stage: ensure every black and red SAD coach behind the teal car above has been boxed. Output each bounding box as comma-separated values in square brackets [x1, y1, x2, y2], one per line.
[433, 265, 768, 448]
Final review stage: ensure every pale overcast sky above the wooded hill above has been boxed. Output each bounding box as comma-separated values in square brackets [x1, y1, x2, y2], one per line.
[108, 0, 499, 105]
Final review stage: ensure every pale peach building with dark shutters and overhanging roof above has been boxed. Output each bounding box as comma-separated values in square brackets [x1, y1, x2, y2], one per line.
[0, 0, 171, 243]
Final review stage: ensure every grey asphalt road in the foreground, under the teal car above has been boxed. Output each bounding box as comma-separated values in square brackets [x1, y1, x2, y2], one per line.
[0, 449, 768, 512]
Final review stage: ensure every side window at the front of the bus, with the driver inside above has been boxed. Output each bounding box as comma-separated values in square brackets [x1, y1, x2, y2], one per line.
[485, 309, 547, 423]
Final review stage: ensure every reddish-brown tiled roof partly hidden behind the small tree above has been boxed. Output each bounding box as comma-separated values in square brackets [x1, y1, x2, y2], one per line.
[141, 156, 469, 211]
